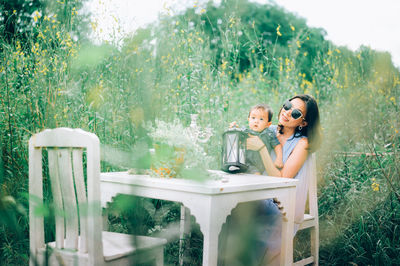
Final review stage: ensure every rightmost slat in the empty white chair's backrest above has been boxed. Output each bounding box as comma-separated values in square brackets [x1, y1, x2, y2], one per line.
[72, 149, 88, 253]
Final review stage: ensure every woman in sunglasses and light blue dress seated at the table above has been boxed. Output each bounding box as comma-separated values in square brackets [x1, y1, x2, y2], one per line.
[219, 95, 321, 265]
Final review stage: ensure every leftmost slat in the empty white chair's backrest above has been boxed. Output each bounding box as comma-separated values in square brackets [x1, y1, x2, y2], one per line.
[48, 149, 65, 248]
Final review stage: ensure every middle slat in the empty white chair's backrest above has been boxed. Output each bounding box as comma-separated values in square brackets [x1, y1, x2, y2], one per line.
[57, 149, 79, 250]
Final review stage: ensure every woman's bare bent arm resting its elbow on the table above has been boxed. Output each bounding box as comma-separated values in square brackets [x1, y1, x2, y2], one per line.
[247, 136, 308, 178]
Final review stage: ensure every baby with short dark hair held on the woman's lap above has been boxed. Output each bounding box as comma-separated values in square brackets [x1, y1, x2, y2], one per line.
[246, 104, 283, 174]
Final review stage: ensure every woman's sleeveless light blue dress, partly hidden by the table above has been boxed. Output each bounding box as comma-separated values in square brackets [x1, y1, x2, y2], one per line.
[218, 125, 312, 265]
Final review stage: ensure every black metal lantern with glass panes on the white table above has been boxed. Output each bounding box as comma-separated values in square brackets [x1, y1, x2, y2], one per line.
[222, 128, 248, 173]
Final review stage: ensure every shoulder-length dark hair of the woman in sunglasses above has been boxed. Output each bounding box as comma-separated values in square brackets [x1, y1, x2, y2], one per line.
[278, 94, 322, 152]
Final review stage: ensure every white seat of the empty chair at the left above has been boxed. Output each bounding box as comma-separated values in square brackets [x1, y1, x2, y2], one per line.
[43, 231, 167, 261]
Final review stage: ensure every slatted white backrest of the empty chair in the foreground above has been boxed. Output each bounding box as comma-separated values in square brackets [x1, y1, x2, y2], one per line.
[29, 128, 103, 265]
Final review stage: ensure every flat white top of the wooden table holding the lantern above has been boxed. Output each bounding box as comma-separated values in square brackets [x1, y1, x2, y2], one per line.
[100, 170, 298, 194]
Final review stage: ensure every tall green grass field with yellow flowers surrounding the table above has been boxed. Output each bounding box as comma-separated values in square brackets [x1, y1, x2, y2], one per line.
[0, 3, 400, 265]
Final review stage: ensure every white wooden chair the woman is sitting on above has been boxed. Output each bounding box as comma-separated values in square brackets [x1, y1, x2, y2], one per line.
[294, 154, 319, 266]
